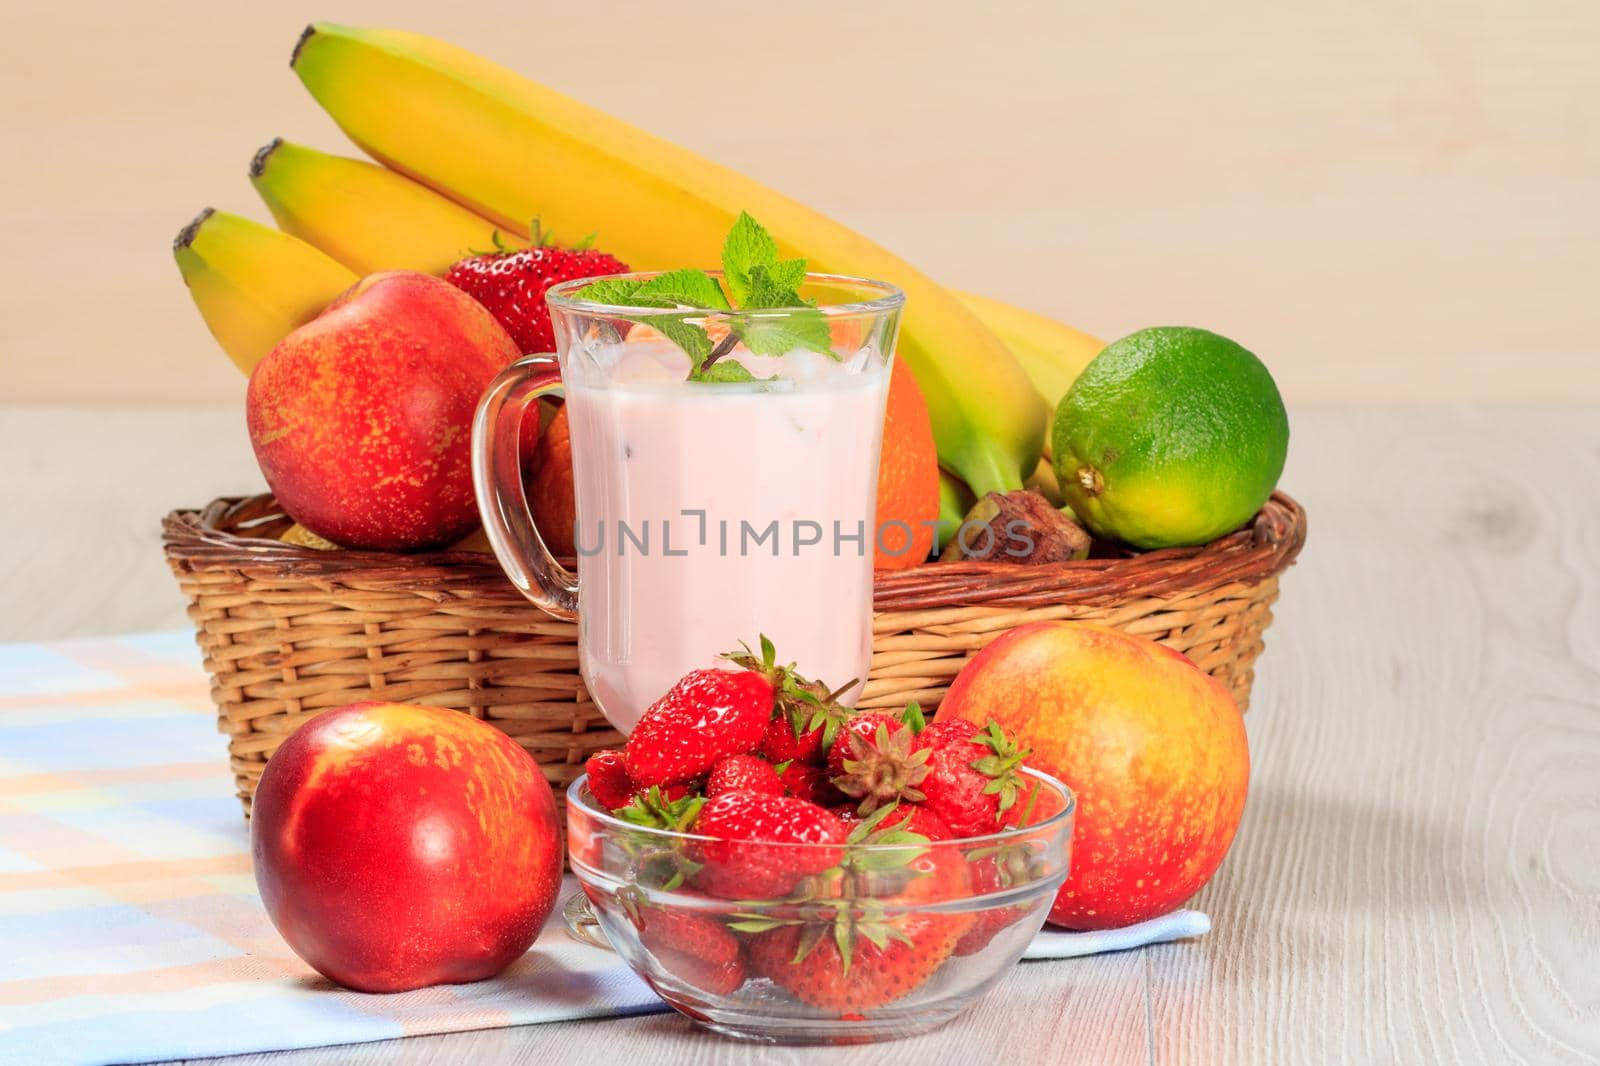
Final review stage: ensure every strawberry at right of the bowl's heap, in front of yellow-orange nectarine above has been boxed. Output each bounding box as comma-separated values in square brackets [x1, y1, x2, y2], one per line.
[918, 719, 1027, 837]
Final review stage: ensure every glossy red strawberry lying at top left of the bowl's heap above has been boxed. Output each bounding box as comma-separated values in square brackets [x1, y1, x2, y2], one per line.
[622, 669, 773, 786]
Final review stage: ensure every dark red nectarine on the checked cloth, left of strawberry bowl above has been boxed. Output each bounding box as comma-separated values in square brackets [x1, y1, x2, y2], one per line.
[250, 703, 562, 992]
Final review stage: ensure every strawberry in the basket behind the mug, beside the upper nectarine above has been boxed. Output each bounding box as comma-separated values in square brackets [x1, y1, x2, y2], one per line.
[445, 222, 627, 355]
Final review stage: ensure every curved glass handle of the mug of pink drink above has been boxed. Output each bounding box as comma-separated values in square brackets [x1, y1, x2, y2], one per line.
[472, 355, 578, 621]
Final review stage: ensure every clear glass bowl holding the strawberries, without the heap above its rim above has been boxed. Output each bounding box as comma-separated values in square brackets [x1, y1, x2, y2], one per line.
[566, 770, 1074, 1044]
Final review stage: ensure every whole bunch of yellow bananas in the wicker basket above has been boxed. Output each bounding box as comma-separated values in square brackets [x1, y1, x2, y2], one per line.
[175, 22, 1099, 495]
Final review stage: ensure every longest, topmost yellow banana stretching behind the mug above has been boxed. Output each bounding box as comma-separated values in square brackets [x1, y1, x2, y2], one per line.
[291, 22, 1048, 491]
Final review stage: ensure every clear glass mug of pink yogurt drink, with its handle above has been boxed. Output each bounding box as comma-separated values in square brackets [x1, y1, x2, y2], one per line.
[472, 274, 904, 733]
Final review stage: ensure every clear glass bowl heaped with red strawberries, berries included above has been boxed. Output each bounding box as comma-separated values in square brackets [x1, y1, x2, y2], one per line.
[566, 640, 1074, 1044]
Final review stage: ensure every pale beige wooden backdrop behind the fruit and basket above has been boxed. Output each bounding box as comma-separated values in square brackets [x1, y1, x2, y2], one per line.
[0, 0, 1600, 405]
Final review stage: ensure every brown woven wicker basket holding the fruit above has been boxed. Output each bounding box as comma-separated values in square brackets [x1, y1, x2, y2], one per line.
[163, 493, 1306, 816]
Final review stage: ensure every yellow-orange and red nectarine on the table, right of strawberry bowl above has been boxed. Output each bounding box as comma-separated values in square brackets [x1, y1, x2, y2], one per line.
[930, 621, 1250, 928]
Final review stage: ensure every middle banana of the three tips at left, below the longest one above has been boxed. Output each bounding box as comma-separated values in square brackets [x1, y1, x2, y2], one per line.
[250, 138, 496, 275]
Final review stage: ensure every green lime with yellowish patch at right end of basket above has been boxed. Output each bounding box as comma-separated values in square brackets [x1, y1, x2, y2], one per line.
[1051, 327, 1290, 547]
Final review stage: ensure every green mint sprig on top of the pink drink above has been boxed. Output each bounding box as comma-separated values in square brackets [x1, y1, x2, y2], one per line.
[576, 211, 838, 383]
